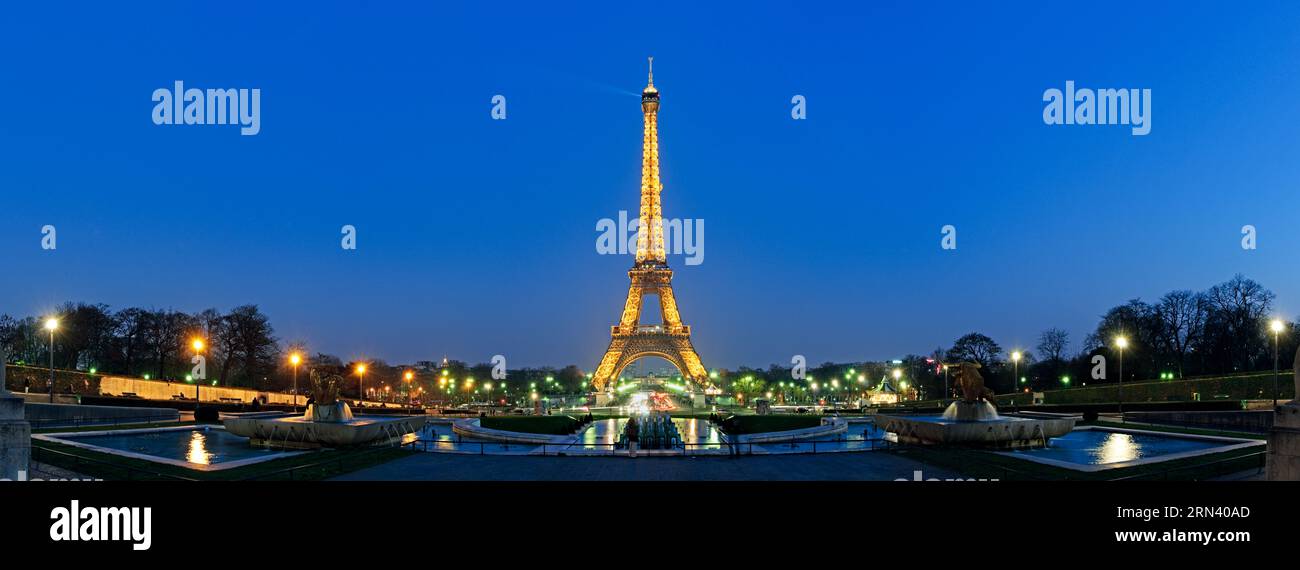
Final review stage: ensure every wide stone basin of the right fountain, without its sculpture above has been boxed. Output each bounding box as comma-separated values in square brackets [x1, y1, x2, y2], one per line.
[876, 414, 1075, 448]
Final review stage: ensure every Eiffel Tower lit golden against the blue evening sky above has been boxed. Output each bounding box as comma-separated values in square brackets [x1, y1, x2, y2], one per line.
[592, 57, 709, 392]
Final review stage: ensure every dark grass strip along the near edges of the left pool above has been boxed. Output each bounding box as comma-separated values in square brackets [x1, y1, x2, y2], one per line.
[31, 440, 412, 480]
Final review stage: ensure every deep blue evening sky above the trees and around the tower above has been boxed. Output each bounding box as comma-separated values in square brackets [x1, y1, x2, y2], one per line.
[0, 1, 1300, 367]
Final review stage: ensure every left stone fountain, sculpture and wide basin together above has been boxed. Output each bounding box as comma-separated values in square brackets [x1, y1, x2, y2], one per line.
[222, 370, 426, 449]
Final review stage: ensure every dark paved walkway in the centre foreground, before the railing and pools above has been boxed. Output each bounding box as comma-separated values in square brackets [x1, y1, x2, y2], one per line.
[338, 452, 959, 482]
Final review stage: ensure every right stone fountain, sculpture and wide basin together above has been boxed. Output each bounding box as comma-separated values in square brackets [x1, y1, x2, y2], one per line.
[876, 362, 1075, 448]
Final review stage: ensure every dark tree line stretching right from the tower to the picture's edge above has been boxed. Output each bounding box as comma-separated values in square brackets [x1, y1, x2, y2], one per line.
[719, 275, 1300, 401]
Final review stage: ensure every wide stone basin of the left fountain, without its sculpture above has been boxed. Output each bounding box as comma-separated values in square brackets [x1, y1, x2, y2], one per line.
[221, 415, 428, 449]
